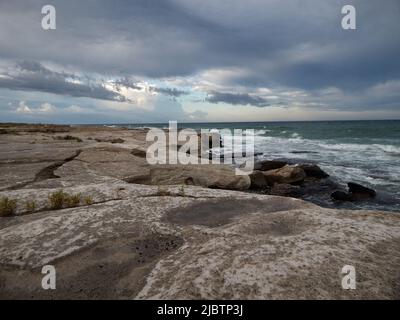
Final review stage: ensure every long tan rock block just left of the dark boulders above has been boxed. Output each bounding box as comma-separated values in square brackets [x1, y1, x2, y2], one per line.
[150, 164, 251, 190]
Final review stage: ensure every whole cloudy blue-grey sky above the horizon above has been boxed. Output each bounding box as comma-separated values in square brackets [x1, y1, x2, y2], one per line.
[0, 0, 400, 124]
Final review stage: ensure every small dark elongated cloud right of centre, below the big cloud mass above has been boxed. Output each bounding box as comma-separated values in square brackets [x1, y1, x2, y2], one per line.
[206, 92, 271, 108]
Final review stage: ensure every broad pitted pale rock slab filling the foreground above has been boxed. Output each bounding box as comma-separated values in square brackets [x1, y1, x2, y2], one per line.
[0, 184, 400, 299]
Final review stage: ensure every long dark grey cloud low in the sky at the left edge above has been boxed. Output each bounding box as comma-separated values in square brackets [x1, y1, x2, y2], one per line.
[0, 61, 126, 101]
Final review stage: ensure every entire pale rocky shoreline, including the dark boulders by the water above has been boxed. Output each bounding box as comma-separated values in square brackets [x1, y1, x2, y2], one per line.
[0, 124, 400, 299]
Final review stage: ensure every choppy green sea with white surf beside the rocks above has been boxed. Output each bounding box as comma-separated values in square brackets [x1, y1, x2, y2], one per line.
[107, 120, 400, 212]
